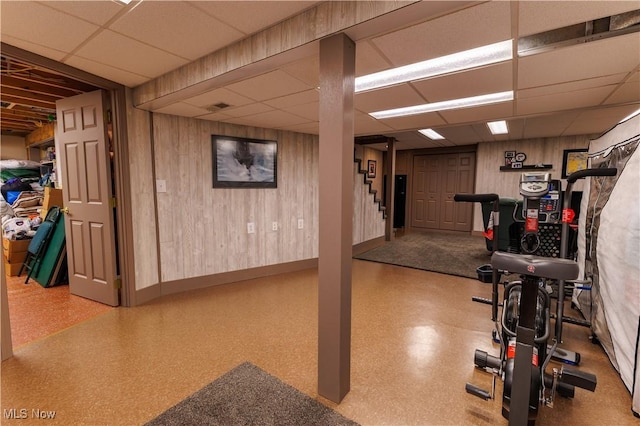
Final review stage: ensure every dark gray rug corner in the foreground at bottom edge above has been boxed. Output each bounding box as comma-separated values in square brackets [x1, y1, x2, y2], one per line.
[147, 362, 358, 426]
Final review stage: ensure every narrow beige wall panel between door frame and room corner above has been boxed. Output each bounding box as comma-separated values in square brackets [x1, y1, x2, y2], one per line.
[127, 90, 159, 290]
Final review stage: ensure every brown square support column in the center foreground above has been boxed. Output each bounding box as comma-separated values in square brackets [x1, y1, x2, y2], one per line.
[318, 34, 356, 403]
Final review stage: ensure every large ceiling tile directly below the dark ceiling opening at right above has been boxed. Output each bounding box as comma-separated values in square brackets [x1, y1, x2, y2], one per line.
[518, 33, 640, 89]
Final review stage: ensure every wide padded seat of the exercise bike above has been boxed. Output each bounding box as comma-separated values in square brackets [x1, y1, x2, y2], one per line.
[491, 251, 578, 280]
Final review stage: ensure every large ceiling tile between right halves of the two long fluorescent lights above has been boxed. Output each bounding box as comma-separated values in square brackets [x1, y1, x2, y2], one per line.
[412, 61, 513, 102]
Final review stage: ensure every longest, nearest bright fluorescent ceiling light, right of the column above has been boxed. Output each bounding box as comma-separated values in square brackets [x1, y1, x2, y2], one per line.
[355, 40, 513, 93]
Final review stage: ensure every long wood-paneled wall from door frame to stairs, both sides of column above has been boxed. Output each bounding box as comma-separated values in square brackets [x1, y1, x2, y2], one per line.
[134, 110, 384, 289]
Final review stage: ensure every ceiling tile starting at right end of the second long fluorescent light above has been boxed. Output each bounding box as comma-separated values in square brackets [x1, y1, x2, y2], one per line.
[516, 85, 616, 115]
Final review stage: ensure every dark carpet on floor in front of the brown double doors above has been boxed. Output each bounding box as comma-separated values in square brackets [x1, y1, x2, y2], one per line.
[354, 232, 491, 279]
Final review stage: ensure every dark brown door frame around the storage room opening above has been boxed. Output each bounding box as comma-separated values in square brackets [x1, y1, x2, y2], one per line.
[1, 43, 136, 310]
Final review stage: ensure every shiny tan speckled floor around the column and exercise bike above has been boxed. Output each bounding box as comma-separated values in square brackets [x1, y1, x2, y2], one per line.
[1, 261, 638, 425]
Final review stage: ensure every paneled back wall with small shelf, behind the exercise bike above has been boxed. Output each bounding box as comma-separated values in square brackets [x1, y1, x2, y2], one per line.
[473, 135, 596, 232]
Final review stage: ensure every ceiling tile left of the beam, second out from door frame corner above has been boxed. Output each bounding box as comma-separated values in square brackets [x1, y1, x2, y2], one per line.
[77, 30, 187, 78]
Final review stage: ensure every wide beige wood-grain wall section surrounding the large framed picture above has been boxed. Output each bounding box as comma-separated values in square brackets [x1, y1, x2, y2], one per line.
[153, 114, 318, 281]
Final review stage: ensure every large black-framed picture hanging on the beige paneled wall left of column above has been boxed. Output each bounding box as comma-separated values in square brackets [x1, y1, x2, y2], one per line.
[211, 135, 278, 188]
